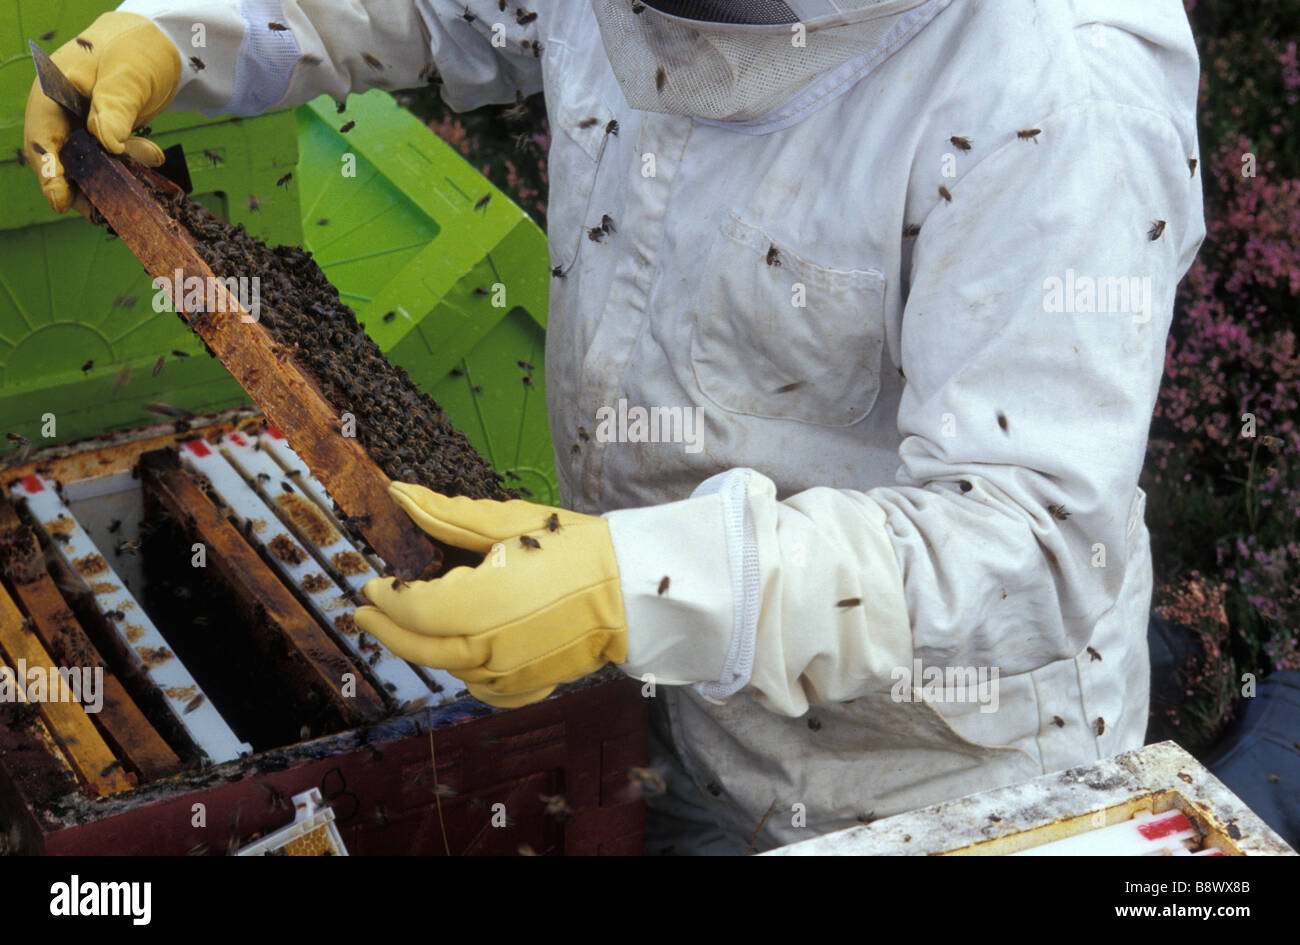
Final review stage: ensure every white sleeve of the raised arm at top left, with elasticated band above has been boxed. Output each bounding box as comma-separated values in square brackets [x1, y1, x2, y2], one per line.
[118, 0, 546, 114]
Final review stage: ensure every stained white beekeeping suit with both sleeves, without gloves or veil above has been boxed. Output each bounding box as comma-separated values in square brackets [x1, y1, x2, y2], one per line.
[116, 0, 1204, 848]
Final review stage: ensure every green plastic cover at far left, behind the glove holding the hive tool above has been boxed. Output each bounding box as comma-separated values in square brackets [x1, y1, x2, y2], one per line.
[0, 0, 302, 450]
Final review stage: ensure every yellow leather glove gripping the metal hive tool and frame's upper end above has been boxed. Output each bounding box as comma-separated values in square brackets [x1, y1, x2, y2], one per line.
[23, 10, 181, 216]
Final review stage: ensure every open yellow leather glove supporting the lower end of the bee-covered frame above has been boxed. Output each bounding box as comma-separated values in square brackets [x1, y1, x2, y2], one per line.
[355, 482, 628, 707]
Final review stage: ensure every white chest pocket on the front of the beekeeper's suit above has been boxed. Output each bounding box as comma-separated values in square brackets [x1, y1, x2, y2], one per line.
[690, 214, 885, 426]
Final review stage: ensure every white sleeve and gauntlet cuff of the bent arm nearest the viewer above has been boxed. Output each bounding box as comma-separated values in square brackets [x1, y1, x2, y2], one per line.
[607, 101, 1205, 716]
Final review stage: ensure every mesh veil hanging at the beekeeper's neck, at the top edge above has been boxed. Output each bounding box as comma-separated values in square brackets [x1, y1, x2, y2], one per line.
[592, 0, 949, 121]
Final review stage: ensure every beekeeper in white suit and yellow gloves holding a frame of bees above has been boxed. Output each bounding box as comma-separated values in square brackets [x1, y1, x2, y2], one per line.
[27, 0, 1204, 853]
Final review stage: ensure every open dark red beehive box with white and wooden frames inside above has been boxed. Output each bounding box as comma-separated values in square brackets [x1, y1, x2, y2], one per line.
[0, 415, 645, 855]
